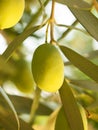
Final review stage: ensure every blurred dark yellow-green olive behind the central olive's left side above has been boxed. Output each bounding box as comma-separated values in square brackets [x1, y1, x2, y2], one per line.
[11, 58, 36, 94]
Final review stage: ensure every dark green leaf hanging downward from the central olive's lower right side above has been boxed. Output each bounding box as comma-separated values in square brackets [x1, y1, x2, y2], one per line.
[59, 81, 84, 130]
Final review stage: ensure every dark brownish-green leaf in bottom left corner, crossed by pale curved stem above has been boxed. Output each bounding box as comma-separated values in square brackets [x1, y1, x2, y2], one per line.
[0, 91, 33, 130]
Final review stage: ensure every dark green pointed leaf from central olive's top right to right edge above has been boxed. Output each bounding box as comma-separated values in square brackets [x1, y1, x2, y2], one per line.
[60, 46, 98, 82]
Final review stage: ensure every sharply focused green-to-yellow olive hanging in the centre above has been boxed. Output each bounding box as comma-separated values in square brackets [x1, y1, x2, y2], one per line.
[32, 43, 64, 92]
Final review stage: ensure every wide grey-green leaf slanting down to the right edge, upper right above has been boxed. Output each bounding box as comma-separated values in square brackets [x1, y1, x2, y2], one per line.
[70, 8, 98, 41]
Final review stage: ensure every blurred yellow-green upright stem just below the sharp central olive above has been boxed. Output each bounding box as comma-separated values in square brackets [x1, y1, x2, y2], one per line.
[29, 87, 41, 124]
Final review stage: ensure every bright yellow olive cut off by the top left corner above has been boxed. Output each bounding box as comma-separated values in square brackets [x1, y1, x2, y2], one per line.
[0, 0, 25, 29]
